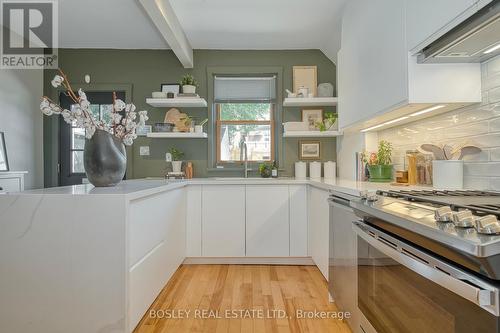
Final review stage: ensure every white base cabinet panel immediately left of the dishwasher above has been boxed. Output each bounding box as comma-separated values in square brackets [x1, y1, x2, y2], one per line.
[307, 186, 330, 280]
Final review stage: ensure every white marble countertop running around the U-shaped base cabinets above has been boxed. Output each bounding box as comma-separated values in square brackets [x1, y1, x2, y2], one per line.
[13, 177, 429, 200]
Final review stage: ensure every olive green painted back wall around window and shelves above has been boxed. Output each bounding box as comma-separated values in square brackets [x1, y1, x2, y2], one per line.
[44, 49, 336, 182]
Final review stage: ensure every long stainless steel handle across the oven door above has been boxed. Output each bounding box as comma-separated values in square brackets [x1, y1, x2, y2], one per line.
[353, 222, 499, 316]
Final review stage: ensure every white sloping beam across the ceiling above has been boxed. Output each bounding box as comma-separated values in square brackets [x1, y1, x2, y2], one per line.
[139, 0, 194, 68]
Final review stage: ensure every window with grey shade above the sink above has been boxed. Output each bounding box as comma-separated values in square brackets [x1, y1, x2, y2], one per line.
[215, 76, 276, 164]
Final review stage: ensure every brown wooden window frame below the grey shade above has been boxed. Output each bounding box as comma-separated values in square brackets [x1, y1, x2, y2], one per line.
[215, 102, 276, 165]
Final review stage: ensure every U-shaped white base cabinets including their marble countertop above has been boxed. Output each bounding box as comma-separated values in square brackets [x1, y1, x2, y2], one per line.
[0, 178, 430, 333]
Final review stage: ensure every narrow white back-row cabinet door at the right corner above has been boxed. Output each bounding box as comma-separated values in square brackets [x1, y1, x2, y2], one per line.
[289, 185, 308, 257]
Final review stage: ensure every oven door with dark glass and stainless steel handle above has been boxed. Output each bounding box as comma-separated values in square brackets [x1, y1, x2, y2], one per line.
[352, 221, 500, 333]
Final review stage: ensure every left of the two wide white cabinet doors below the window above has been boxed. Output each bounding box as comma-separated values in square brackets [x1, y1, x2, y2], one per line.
[202, 185, 245, 257]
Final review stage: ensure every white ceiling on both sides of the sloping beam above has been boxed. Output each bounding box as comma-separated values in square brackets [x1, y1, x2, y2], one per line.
[59, 0, 348, 59]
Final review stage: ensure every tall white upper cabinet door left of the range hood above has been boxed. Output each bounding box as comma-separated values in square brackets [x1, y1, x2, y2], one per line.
[338, 0, 408, 128]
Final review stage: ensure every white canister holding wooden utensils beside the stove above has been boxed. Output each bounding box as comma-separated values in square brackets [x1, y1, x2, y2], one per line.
[432, 160, 464, 189]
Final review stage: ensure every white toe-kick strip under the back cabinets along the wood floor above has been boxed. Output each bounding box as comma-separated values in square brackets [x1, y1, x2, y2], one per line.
[183, 257, 314, 266]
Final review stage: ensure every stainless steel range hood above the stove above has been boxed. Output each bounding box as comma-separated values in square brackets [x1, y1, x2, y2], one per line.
[418, 0, 500, 63]
